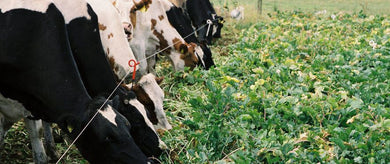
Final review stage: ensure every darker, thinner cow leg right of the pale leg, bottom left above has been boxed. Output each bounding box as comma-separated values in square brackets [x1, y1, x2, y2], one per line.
[42, 121, 59, 161]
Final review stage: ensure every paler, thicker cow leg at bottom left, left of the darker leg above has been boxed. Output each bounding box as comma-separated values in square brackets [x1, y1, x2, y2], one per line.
[24, 119, 47, 164]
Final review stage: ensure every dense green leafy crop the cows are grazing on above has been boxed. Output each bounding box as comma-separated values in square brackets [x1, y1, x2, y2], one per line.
[158, 11, 390, 163]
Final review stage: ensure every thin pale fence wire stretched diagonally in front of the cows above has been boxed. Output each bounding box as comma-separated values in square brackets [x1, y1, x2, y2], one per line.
[56, 18, 215, 164]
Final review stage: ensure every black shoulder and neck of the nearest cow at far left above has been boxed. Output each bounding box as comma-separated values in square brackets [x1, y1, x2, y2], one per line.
[0, 4, 88, 122]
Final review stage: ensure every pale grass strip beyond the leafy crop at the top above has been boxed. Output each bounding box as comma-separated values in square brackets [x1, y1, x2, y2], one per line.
[211, 0, 390, 17]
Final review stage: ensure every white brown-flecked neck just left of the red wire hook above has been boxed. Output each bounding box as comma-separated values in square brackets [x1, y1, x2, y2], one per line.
[87, 0, 138, 79]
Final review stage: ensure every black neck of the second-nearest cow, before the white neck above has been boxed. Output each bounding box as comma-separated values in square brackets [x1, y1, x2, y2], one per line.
[66, 6, 117, 97]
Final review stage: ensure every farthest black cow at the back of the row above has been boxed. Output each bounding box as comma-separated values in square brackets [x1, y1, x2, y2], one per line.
[185, 0, 223, 44]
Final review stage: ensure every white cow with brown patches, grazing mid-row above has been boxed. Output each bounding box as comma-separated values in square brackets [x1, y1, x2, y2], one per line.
[130, 0, 198, 74]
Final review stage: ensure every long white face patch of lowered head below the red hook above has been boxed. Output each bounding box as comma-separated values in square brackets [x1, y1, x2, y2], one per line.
[138, 74, 172, 130]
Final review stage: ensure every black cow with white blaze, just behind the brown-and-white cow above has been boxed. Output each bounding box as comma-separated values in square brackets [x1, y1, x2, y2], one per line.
[166, 6, 214, 70]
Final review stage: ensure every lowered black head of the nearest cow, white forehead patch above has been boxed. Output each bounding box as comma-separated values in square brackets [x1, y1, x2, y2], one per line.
[59, 97, 154, 163]
